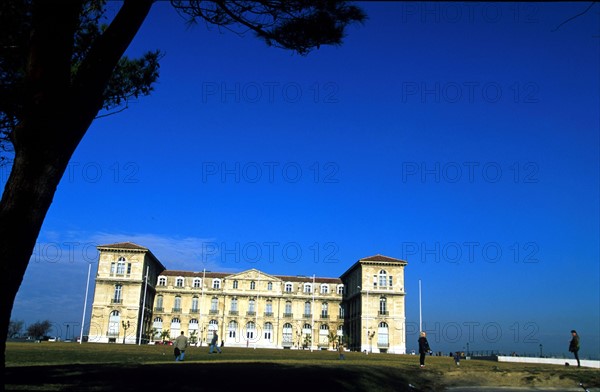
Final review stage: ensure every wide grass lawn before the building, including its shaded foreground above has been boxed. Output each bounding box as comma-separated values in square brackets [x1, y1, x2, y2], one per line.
[4, 342, 600, 392]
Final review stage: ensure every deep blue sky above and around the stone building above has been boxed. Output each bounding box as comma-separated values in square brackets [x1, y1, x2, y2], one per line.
[1, 2, 600, 358]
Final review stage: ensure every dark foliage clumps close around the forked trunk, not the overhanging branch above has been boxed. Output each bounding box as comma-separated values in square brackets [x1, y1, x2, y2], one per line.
[0, 0, 161, 164]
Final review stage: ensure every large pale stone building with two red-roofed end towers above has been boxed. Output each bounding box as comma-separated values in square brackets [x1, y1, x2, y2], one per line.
[89, 242, 406, 354]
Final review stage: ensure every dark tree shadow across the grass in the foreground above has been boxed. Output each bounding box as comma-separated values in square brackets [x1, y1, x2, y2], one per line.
[4, 362, 432, 392]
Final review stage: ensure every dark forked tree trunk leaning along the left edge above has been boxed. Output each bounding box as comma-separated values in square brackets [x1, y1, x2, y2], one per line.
[0, 0, 153, 380]
